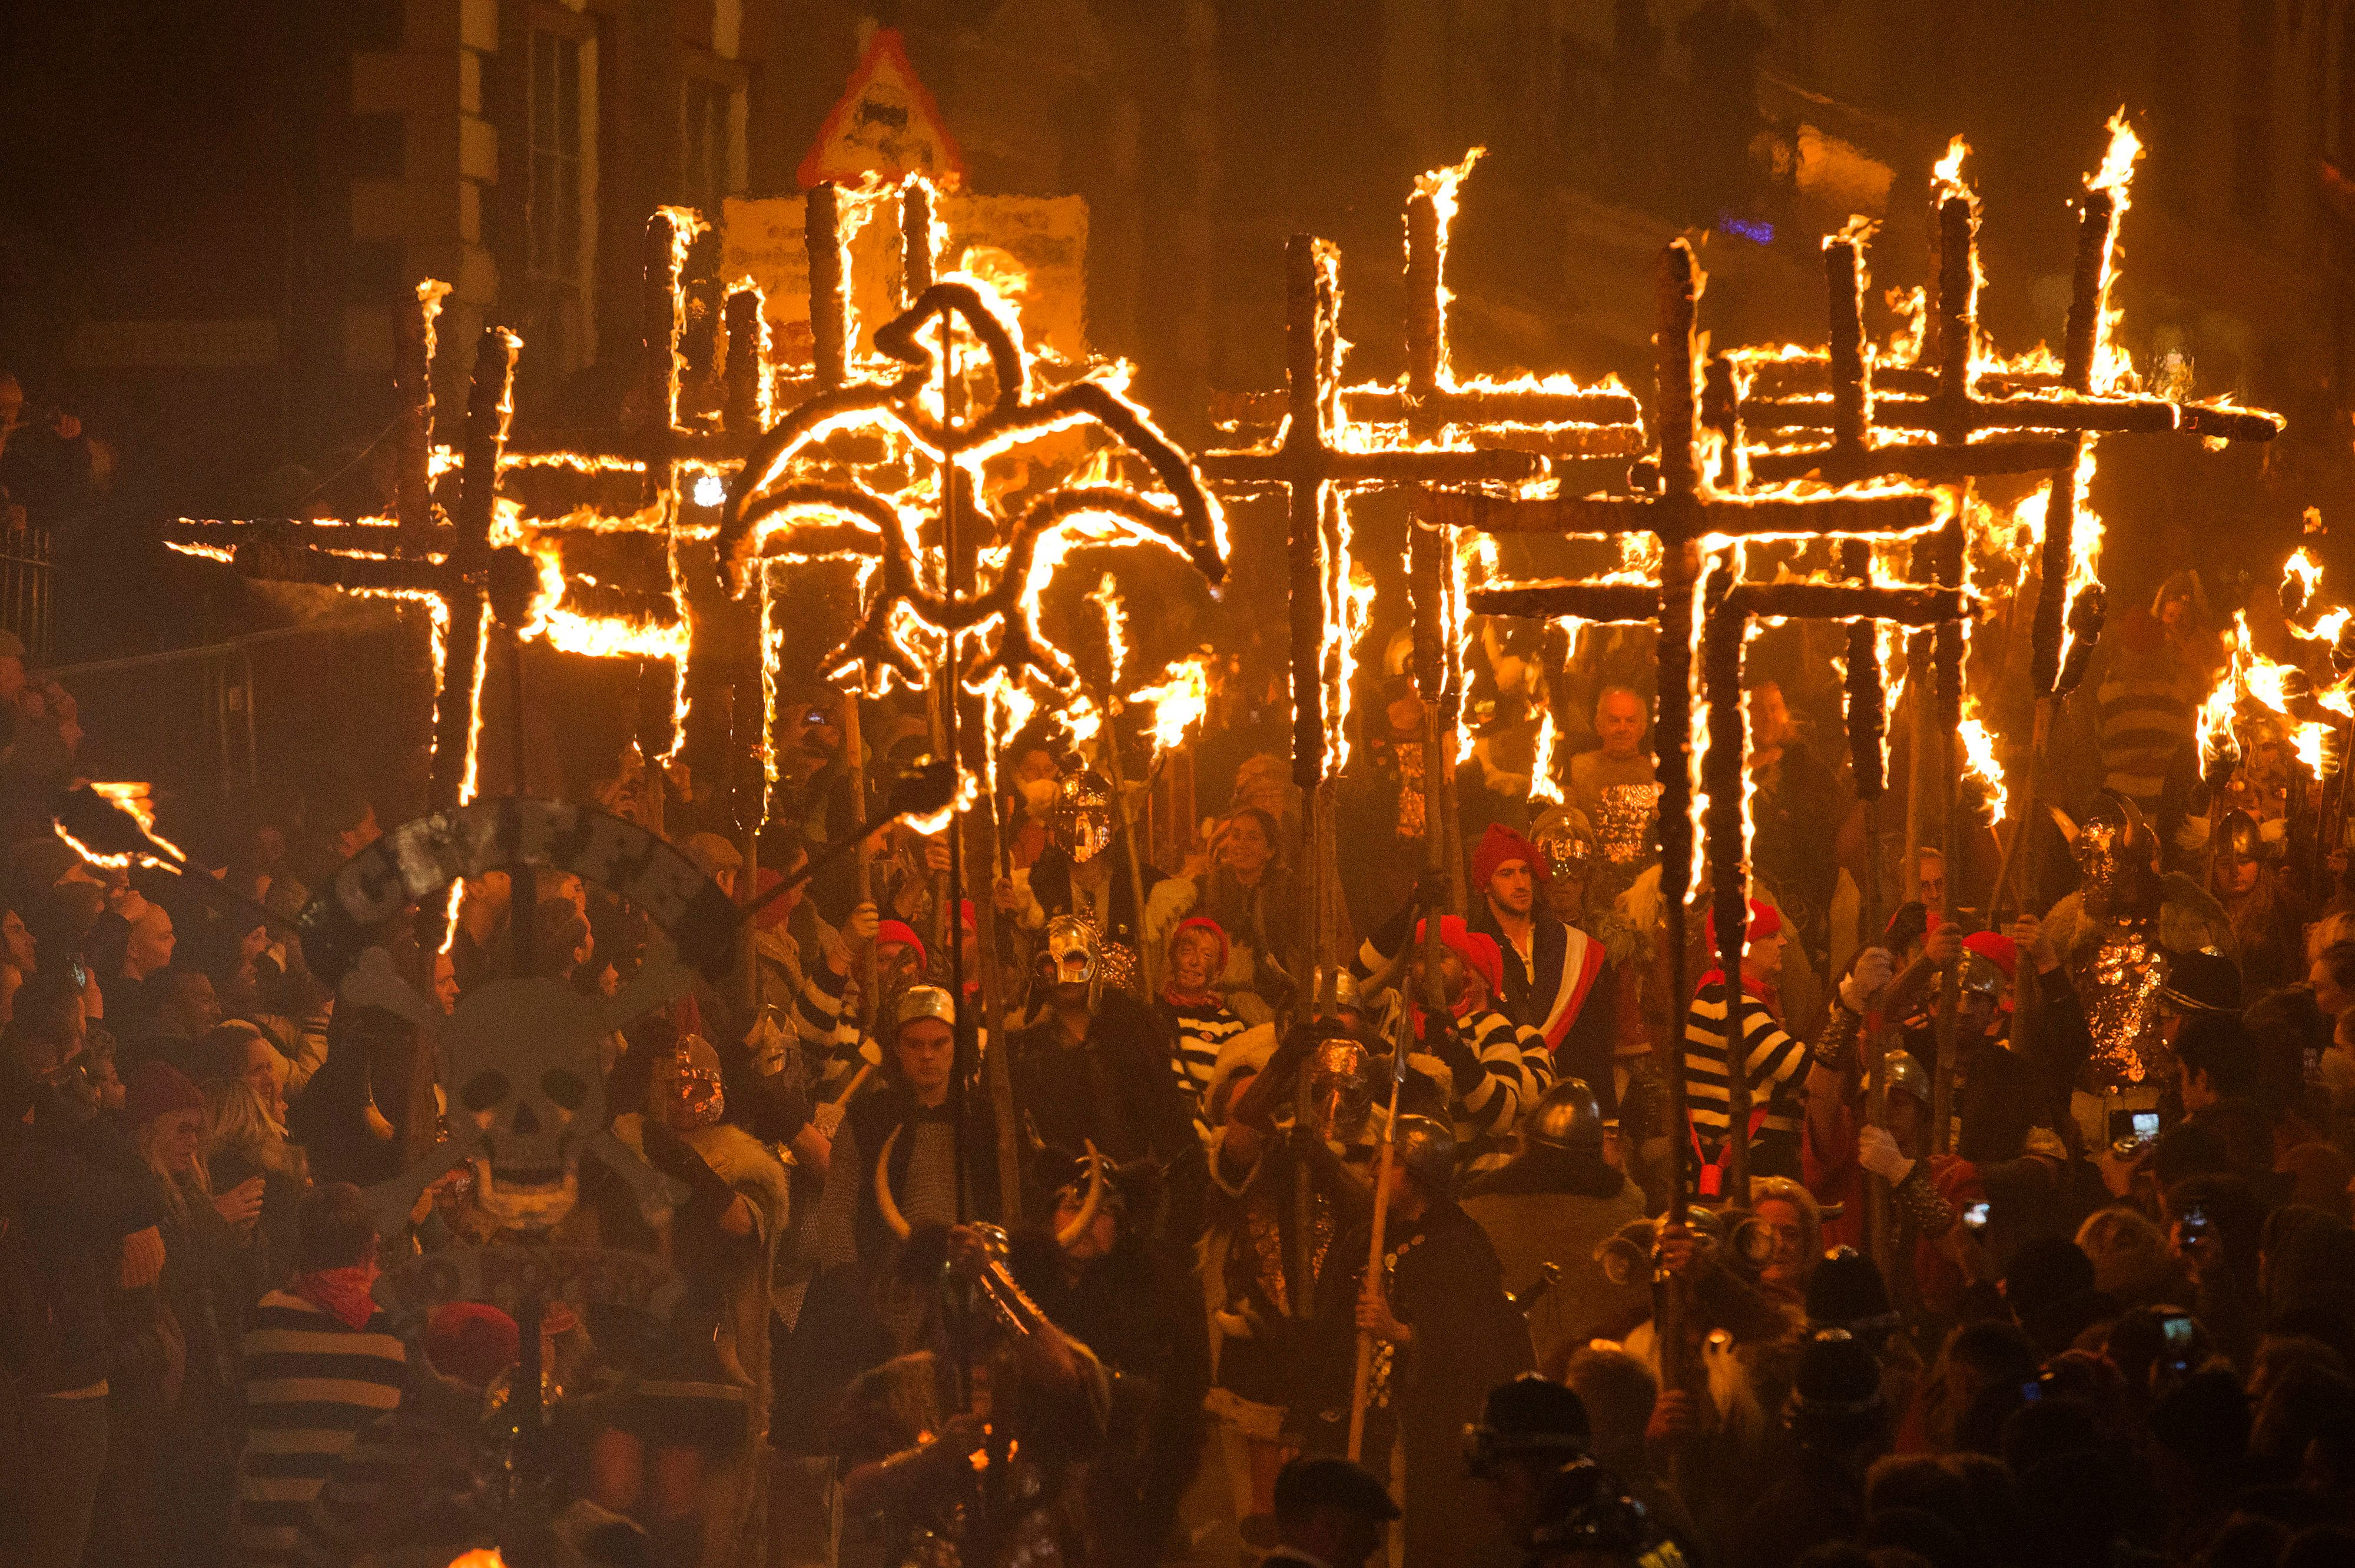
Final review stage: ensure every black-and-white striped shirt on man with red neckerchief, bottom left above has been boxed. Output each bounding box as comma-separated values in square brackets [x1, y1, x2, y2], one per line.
[238, 1290, 407, 1568]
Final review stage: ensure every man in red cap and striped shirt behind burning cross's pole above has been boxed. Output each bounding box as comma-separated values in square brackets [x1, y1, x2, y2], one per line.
[1684, 899, 1806, 1177]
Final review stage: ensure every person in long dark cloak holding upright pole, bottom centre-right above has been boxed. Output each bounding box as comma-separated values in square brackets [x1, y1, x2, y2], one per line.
[1286, 1116, 1531, 1568]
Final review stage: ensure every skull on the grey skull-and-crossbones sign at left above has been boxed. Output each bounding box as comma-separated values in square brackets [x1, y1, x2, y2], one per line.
[443, 979, 615, 1231]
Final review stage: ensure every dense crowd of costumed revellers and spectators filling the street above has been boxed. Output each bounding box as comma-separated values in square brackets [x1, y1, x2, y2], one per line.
[0, 532, 2355, 1568]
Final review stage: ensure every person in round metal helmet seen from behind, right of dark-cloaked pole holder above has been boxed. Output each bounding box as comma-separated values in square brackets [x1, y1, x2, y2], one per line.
[1462, 1078, 1646, 1368]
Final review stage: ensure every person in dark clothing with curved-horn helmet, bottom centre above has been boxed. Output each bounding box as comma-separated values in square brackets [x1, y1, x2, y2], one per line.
[1008, 1156, 1210, 1563]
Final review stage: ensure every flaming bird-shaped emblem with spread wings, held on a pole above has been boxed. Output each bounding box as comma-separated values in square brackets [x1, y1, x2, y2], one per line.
[716, 275, 1227, 690]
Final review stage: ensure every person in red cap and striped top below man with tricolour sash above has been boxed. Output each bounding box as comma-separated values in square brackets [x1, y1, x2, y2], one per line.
[1356, 904, 1554, 1170]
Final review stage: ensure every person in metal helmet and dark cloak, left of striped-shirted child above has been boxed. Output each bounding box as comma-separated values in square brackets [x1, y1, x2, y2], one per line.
[1013, 916, 1194, 1165]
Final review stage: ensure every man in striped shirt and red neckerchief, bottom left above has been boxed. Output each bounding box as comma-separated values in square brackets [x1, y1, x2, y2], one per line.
[236, 1182, 407, 1568]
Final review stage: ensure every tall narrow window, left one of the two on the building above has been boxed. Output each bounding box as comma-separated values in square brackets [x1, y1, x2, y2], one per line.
[523, 28, 596, 370]
